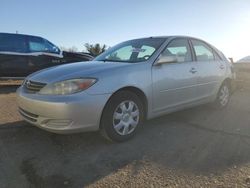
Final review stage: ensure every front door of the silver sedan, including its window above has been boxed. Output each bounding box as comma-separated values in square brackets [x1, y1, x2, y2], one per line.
[152, 38, 198, 112]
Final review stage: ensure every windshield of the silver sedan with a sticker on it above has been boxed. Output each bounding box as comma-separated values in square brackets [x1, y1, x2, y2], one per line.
[94, 38, 166, 63]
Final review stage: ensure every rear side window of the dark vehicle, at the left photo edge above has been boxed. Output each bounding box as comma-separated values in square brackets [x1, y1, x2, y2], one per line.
[0, 34, 27, 53]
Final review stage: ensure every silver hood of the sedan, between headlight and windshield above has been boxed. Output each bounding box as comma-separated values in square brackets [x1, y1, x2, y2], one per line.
[27, 61, 130, 83]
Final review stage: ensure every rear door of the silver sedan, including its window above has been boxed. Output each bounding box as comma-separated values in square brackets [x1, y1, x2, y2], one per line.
[191, 39, 226, 99]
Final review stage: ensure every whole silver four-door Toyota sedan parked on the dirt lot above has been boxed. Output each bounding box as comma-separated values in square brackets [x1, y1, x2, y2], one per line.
[17, 36, 233, 141]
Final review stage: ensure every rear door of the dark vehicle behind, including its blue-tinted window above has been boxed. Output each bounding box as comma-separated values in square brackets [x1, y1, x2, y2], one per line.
[0, 34, 28, 78]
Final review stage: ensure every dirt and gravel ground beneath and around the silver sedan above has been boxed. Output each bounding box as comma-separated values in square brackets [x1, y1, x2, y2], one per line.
[0, 87, 250, 188]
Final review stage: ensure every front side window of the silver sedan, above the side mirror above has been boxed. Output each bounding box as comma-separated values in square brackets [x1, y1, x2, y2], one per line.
[161, 39, 192, 63]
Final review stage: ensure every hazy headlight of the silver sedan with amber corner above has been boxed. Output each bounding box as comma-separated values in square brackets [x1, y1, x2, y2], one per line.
[39, 78, 97, 95]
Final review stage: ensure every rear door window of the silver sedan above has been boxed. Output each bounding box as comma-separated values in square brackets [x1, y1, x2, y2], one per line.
[191, 40, 214, 61]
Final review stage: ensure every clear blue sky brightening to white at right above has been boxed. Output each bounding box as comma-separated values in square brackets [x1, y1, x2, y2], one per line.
[0, 0, 250, 60]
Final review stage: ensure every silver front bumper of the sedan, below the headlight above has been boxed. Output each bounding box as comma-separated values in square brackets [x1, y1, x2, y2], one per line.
[17, 87, 111, 134]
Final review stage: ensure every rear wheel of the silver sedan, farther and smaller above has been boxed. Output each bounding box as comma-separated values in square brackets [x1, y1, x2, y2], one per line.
[215, 82, 231, 109]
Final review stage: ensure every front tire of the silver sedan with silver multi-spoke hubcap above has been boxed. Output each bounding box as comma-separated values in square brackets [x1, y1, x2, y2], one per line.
[100, 91, 144, 142]
